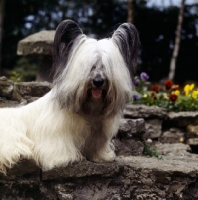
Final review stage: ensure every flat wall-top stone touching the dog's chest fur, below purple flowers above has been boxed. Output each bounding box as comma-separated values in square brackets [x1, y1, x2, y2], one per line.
[124, 104, 168, 119]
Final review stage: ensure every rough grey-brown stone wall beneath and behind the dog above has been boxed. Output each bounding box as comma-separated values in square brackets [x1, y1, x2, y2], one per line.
[0, 77, 198, 200]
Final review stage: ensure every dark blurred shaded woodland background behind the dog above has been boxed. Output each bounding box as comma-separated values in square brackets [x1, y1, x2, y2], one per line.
[0, 0, 198, 84]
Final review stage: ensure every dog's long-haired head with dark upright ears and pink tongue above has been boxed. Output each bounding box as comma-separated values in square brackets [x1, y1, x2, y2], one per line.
[53, 20, 139, 115]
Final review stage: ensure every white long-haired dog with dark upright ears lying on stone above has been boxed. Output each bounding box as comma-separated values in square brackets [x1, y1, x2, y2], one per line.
[0, 20, 139, 173]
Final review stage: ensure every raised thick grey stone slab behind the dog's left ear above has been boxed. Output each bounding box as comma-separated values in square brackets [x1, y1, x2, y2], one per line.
[17, 30, 55, 56]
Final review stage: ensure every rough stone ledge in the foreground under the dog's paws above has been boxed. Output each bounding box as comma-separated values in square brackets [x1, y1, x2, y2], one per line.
[0, 156, 198, 200]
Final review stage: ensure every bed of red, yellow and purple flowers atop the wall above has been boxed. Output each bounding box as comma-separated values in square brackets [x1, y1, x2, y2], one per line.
[133, 72, 198, 112]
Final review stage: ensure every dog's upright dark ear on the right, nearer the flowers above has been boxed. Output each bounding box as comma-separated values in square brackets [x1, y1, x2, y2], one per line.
[112, 23, 140, 78]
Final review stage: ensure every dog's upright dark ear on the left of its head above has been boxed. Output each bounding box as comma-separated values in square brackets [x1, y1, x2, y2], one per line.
[53, 20, 83, 78]
